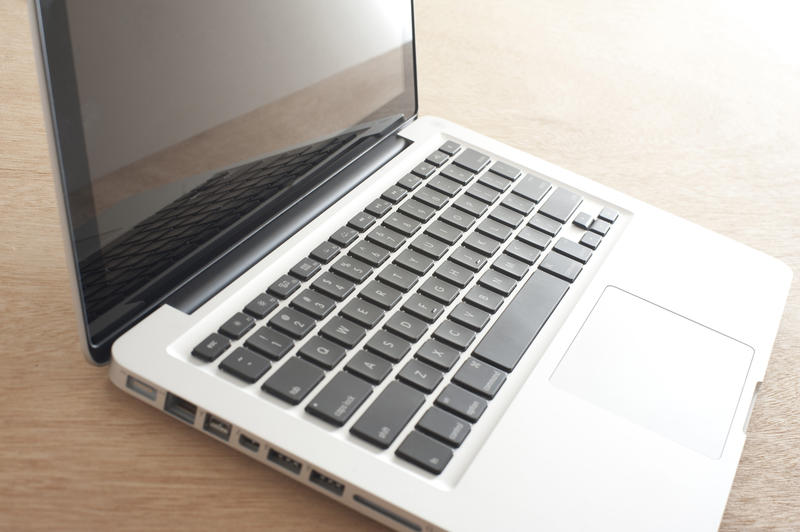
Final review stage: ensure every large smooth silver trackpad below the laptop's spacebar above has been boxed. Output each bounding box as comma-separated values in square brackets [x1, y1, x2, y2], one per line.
[550, 286, 753, 458]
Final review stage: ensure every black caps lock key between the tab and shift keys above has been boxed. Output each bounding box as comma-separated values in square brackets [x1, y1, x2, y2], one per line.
[306, 372, 372, 427]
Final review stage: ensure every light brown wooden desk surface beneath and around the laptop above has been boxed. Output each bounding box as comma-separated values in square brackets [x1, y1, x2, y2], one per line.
[0, 0, 800, 530]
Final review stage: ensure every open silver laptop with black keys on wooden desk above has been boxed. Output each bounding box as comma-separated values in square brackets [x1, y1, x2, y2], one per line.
[31, 0, 791, 531]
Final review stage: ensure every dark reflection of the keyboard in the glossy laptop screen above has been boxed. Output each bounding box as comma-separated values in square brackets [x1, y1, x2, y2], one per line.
[80, 133, 354, 322]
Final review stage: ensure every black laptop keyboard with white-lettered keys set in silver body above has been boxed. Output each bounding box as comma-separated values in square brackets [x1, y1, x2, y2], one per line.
[192, 141, 619, 475]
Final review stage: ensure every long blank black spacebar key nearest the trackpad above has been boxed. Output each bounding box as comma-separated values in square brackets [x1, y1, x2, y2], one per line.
[472, 270, 569, 371]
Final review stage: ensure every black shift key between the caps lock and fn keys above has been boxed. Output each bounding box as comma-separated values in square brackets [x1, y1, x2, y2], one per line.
[350, 381, 425, 449]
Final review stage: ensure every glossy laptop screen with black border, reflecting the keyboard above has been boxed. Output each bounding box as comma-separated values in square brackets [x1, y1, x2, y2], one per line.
[40, 0, 416, 358]
